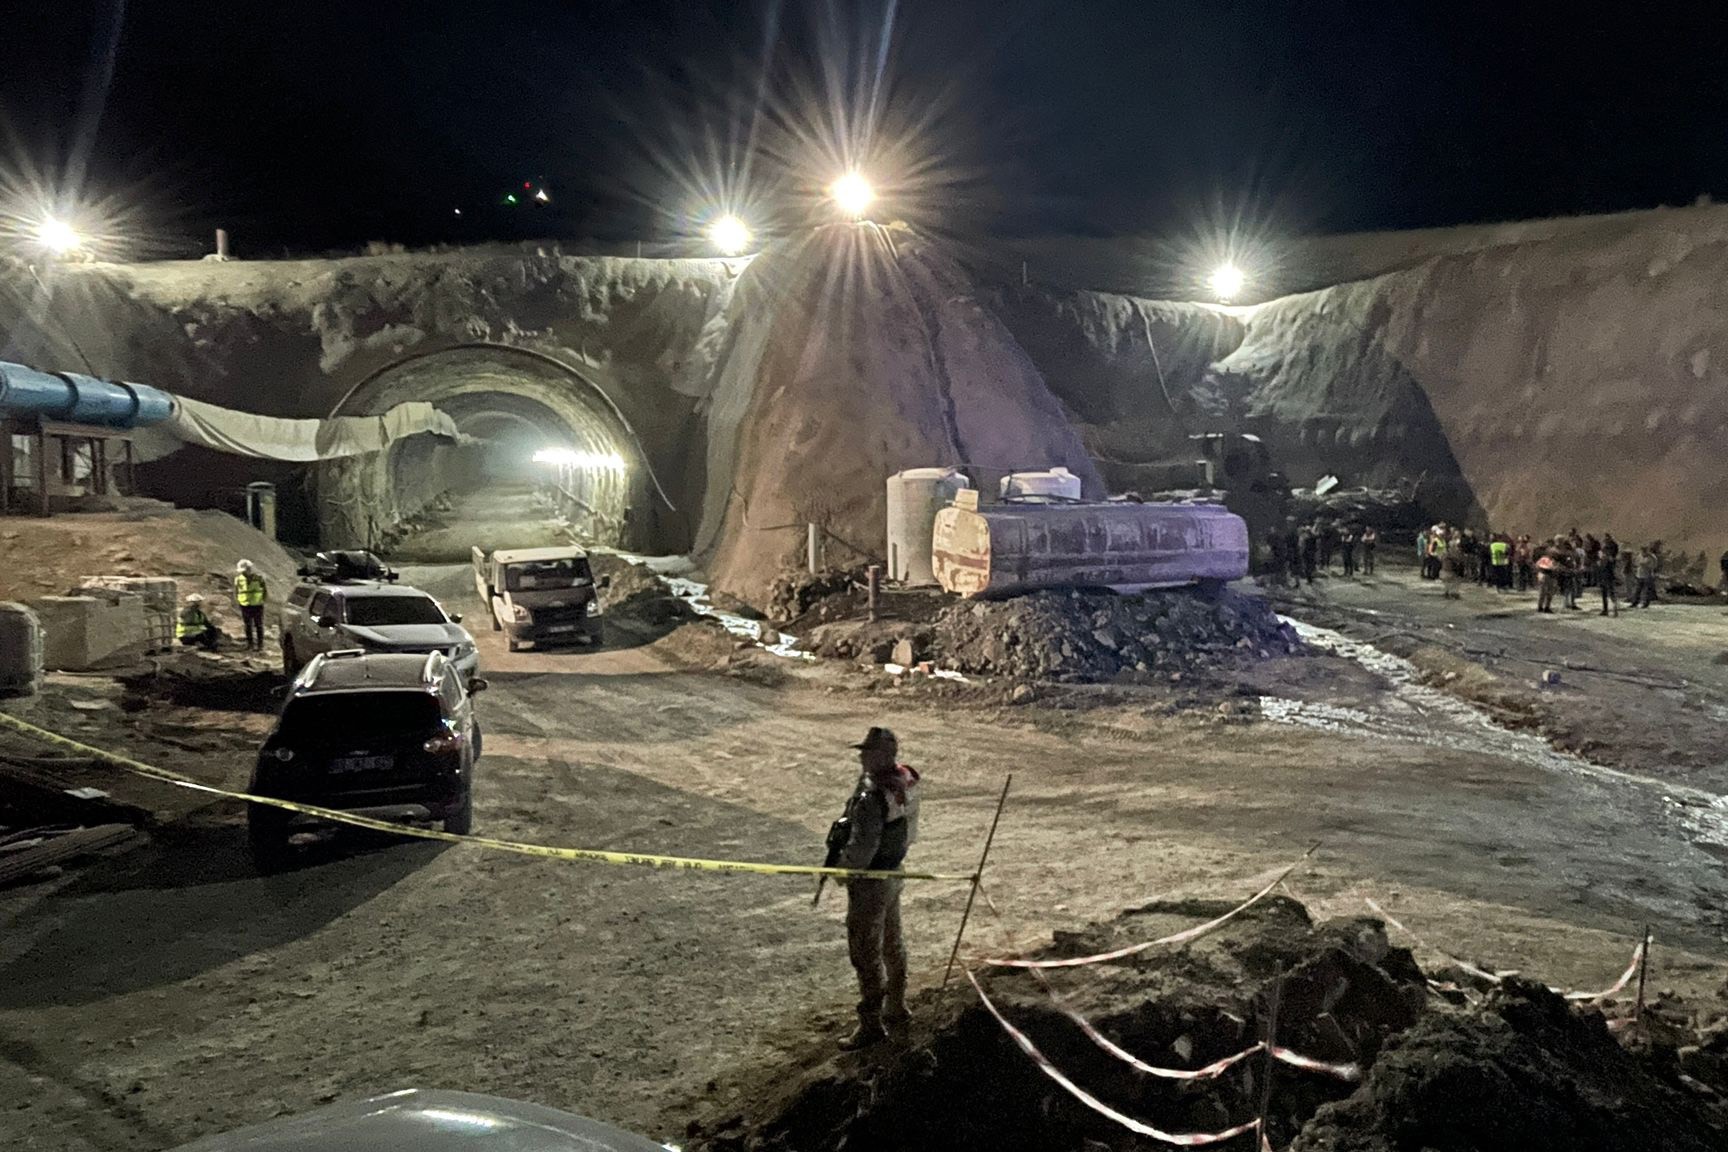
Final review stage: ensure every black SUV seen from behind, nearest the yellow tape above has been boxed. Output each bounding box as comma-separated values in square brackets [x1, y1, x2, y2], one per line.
[247, 651, 486, 872]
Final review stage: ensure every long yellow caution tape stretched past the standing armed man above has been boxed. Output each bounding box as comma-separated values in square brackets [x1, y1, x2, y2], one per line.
[0, 712, 973, 883]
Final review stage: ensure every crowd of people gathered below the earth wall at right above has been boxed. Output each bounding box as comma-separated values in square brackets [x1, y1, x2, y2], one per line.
[1265, 518, 1679, 617]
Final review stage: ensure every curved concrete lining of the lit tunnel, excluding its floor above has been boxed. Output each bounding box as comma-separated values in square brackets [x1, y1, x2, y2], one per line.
[318, 345, 660, 548]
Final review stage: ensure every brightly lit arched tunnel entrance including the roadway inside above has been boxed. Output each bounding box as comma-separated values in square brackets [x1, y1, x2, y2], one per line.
[316, 345, 660, 560]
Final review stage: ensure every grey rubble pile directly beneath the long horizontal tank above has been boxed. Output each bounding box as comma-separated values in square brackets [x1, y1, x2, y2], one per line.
[928, 589, 1301, 682]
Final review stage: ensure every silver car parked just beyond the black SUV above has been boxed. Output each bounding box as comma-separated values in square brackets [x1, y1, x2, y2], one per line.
[282, 580, 480, 680]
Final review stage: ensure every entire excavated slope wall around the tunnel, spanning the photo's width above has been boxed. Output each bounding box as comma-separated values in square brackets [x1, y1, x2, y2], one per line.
[0, 207, 1728, 594]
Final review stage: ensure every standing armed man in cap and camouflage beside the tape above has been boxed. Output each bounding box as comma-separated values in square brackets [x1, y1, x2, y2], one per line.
[836, 727, 918, 1052]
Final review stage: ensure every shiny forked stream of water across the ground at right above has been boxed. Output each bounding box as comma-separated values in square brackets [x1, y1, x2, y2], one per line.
[1260, 617, 1728, 848]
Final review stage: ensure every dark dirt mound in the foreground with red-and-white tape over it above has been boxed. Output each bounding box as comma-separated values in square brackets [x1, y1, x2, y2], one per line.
[689, 898, 1728, 1152]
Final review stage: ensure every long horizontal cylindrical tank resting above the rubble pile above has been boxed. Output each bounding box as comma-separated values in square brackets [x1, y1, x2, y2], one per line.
[931, 503, 1248, 596]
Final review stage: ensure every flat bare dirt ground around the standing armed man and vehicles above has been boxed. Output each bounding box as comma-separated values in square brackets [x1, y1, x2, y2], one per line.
[0, 565, 1728, 1152]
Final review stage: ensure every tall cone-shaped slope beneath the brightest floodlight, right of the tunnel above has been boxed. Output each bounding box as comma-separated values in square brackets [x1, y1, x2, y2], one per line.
[698, 226, 1102, 598]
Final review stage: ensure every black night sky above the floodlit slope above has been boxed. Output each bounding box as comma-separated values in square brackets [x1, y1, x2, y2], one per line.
[0, 0, 1728, 256]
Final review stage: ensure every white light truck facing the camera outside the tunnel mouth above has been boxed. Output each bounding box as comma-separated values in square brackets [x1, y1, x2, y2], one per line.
[473, 546, 612, 651]
